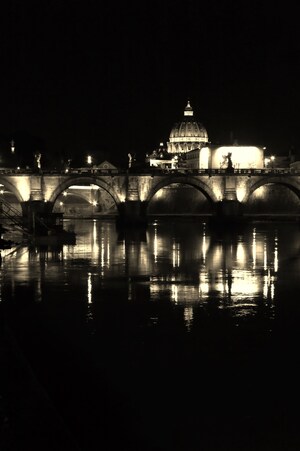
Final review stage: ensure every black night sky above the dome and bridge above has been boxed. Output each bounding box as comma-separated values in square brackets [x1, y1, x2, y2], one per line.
[0, 0, 300, 166]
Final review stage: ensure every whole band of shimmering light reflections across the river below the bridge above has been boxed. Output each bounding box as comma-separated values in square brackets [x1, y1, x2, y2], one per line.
[2, 220, 299, 329]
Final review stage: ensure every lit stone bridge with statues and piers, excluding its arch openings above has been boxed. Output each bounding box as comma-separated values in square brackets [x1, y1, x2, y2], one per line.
[0, 168, 300, 226]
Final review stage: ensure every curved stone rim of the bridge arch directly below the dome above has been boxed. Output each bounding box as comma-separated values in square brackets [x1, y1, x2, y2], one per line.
[146, 176, 217, 204]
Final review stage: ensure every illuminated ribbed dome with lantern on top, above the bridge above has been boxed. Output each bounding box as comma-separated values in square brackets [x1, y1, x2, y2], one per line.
[168, 102, 208, 153]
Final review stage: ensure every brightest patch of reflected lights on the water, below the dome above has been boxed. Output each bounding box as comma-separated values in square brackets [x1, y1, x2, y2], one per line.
[149, 220, 278, 326]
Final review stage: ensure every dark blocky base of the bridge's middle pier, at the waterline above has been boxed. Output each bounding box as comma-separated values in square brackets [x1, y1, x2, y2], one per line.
[117, 200, 147, 227]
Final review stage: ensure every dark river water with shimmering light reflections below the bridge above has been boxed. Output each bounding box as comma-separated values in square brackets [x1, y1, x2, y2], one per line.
[0, 219, 300, 451]
